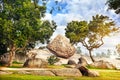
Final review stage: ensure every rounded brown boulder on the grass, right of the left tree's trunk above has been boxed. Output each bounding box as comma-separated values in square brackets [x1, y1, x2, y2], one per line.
[23, 58, 48, 68]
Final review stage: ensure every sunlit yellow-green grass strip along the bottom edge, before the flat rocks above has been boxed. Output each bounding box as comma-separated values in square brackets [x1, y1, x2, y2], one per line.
[0, 69, 120, 80]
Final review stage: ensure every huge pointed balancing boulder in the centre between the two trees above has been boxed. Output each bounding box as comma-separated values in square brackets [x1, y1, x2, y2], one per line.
[47, 35, 76, 58]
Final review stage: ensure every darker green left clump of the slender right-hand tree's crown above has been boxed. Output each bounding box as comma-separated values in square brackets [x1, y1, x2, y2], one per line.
[65, 21, 88, 44]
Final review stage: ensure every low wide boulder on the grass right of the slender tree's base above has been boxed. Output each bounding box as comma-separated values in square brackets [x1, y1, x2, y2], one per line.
[90, 60, 116, 69]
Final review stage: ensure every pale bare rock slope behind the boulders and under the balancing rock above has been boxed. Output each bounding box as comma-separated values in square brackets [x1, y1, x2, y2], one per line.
[25, 49, 120, 69]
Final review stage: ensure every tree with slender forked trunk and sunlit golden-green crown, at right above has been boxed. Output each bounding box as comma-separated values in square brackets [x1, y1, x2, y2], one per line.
[65, 15, 117, 62]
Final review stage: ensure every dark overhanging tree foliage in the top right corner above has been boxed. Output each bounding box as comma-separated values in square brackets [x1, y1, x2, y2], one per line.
[107, 0, 120, 14]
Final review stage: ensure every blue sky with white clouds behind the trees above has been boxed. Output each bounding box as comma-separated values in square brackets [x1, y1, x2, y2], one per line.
[40, 0, 120, 54]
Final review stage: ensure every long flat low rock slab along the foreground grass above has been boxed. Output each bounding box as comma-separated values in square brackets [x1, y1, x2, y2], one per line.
[2, 68, 82, 77]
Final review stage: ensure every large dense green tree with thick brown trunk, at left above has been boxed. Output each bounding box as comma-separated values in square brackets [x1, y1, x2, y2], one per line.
[0, 0, 56, 66]
